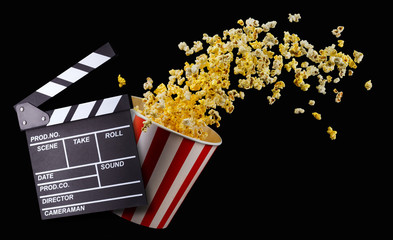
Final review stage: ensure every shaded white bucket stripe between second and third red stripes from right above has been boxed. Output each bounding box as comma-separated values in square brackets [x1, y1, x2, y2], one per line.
[131, 133, 183, 224]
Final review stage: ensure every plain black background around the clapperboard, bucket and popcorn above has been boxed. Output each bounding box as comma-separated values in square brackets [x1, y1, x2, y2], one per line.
[1, 1, 391, 239]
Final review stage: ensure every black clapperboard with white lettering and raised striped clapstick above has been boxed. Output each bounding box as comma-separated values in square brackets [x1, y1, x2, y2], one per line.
[14, 43, 147, 219]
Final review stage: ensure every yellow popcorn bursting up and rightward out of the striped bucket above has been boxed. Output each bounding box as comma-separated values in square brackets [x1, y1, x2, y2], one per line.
[133, 14, 371, 140]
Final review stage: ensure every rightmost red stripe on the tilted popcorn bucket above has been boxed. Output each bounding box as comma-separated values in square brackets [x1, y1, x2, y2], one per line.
[157, 145, 212, 228]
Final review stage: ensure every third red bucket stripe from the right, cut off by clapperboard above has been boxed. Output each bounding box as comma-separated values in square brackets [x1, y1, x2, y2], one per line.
[142, 128, 170, 187]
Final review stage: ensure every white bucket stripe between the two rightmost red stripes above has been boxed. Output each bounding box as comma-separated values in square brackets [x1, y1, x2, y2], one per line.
[150, 143, 204, 228]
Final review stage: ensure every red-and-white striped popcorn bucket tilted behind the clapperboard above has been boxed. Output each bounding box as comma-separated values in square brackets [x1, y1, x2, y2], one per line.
[114, 97, 221, 228]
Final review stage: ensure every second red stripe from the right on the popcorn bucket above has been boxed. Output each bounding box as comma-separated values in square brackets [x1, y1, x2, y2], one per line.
[141, 139, 194, 226]
